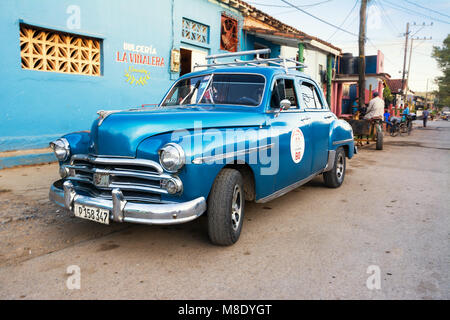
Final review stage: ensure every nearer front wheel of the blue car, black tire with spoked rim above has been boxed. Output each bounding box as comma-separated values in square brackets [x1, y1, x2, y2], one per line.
[208, 168, 245, 246]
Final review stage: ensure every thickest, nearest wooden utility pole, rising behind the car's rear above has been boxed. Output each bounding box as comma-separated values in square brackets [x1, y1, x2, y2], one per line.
[358, 0, 367, 108]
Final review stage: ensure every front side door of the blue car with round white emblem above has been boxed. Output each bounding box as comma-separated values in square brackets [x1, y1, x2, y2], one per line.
[270, 76, 312, 190]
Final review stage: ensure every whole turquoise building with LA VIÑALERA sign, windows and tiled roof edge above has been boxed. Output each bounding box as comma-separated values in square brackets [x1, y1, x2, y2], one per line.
[0, 0, 338, 169]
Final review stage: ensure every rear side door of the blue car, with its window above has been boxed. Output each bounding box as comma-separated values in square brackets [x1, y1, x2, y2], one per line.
[300, 79, 335, 173]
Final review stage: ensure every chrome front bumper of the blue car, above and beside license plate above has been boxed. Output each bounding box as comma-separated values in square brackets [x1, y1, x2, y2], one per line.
[49, 181, 206, 225]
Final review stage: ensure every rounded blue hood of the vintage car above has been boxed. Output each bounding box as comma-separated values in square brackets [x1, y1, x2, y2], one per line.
[89, 106, 265, 157]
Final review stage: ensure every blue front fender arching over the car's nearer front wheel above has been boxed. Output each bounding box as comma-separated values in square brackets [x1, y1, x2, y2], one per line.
[137, 127, 273, 201]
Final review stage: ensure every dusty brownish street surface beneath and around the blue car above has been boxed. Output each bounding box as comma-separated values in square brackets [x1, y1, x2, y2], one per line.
[0, 120, 450, 299]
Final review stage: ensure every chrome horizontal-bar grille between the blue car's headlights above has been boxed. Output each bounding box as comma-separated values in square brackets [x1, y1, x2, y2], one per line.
[66, 155, 172, 200]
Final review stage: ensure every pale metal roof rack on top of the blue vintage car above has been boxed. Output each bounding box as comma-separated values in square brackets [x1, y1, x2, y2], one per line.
[194, 48, 307, 73]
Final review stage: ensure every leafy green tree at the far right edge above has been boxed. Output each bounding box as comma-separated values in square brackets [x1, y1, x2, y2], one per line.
[433, 34, 450, 106]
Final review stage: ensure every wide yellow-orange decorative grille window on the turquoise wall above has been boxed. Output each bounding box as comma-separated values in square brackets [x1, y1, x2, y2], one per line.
[20, 24, 101, 76]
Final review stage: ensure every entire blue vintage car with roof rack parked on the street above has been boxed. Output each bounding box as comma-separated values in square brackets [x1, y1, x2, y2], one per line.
[50, 49, 356, 245]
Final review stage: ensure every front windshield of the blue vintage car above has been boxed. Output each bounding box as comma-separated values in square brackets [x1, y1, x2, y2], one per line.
[161, 74, 265, 106]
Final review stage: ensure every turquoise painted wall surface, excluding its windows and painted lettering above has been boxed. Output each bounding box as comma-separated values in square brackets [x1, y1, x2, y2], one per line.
[0, 0, 248, 169]
